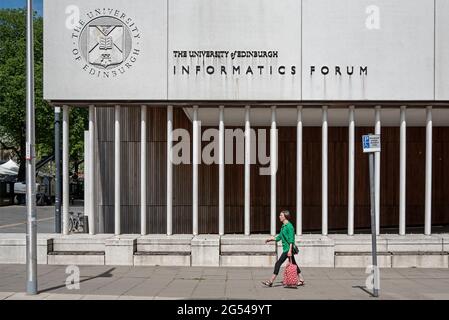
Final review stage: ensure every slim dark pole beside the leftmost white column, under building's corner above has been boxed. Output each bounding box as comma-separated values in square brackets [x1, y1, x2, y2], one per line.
[55, 107, 61, 233]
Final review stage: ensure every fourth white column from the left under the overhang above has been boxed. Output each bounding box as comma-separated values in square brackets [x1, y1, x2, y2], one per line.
[140, 106, 147, 236]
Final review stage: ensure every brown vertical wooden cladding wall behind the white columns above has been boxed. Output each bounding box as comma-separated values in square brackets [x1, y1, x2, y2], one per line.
[97, 106, 449, 234]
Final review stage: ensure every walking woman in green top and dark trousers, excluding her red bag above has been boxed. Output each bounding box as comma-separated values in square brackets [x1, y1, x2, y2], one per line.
[262, 210, 305, 287]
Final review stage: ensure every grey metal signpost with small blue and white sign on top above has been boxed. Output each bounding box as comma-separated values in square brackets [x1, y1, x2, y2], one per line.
[362, 134, 380, 297]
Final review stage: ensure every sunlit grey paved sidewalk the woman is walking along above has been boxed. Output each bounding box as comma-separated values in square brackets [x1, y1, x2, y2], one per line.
[0, 265, 449, 300]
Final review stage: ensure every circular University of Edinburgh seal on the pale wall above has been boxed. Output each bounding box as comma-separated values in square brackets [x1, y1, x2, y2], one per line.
[72, 9, 141, 78]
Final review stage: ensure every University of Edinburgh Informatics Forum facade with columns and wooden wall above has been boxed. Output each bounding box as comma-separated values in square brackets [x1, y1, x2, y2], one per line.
[37, 0, 449, 268]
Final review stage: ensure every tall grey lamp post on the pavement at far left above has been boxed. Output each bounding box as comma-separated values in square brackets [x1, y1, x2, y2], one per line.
[25, 0, 37, 295]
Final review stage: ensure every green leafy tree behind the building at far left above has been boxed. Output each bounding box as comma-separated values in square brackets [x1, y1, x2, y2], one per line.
[0, 9, 87, 181]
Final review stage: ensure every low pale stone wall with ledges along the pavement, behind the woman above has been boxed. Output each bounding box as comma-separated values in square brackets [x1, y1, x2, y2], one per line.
[0, 234, 449, 268]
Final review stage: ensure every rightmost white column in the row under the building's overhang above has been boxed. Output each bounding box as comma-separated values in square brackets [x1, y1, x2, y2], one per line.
[424, 106, 433, 235]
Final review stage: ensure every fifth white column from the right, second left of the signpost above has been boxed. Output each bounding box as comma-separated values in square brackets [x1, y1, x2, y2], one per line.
[321, 106, 328, 236]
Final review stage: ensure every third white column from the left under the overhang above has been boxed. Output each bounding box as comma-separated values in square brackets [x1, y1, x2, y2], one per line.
[114, 105, 121, 235]
